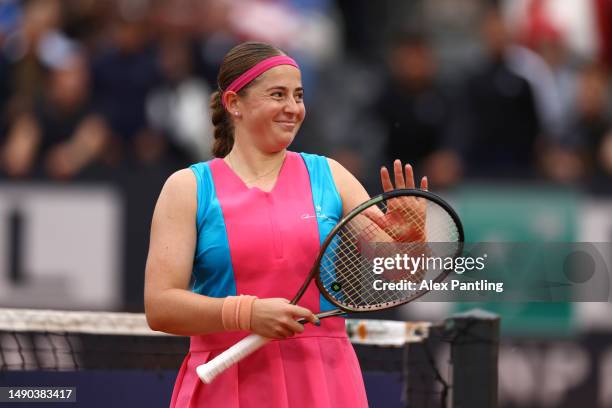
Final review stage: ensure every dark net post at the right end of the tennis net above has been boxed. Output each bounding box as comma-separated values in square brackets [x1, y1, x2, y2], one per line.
[446, 309, 500, 408]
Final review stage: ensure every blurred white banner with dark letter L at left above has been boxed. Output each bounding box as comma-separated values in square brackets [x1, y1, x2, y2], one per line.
[0, 184, 123, 310]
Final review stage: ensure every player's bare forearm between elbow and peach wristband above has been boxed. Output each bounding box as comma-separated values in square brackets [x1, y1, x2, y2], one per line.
[145, 289, 224, 336]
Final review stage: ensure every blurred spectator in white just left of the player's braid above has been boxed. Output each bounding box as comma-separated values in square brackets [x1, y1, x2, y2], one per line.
[147, 37, 213, 162]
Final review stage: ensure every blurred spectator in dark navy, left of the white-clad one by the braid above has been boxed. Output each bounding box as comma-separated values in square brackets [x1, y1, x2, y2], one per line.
[93, 16, 161, 162]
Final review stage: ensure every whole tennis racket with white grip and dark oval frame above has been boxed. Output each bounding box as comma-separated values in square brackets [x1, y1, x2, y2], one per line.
[197, 189, 464, 383]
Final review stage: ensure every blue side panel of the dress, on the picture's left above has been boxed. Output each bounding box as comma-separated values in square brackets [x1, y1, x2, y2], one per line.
[190, 162, 236, 298]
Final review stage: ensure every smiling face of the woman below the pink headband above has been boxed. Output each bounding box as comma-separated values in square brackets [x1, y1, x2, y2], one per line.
[228, 65, 306, 153]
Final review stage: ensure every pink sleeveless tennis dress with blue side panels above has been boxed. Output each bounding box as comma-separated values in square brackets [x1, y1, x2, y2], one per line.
[170, 152, 367, 408]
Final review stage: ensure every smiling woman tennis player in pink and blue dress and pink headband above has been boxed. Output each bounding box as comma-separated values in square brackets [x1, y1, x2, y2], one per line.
[145, 42, 427, 408]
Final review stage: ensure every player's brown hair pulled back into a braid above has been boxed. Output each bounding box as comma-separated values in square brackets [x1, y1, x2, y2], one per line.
[210, 42, 286, 157]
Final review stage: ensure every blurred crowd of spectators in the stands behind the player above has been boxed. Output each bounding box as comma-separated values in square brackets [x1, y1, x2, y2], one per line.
[0, 0, 612, 191]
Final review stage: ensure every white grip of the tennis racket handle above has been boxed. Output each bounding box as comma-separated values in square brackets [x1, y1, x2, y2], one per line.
[196, 334, 271, 384]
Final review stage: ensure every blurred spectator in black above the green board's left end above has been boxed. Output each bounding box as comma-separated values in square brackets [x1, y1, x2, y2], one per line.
[454, 11, 540, 177]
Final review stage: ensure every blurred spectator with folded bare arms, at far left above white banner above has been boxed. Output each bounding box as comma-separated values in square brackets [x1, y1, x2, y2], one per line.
[1, 55, 107, 179]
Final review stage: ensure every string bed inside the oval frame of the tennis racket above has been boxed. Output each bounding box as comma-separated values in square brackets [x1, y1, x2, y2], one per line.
[319, 197, 459, 311]
